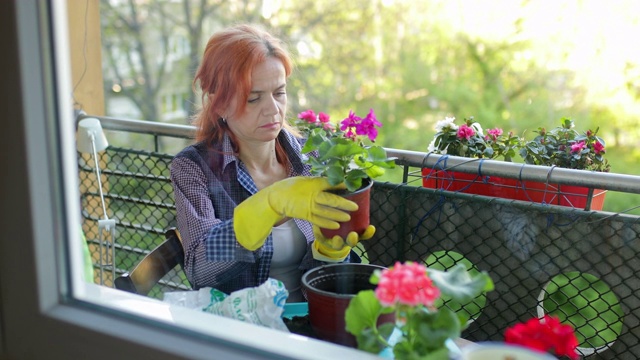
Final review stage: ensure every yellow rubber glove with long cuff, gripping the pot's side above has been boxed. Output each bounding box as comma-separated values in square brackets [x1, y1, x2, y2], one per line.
[233, 176, 358, 251]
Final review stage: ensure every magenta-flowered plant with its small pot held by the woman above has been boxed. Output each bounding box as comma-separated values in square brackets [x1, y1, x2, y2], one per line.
[295, 109, 395, 238]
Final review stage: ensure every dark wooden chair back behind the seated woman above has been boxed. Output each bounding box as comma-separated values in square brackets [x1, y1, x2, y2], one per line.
[114, 228, 184, 295]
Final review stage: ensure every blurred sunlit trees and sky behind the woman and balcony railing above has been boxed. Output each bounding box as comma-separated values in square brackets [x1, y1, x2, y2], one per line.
[101, 0, 640, 211]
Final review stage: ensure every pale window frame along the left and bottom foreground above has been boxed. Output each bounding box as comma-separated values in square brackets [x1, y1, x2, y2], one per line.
[0, 0, 376, 360]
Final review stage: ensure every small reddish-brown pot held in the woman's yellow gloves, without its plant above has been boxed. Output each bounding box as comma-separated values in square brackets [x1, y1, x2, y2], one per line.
[320, 178, 373, 239]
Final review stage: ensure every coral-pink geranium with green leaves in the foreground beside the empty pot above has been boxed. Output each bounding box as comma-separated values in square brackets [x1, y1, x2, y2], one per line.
[345, 261, 493, 359]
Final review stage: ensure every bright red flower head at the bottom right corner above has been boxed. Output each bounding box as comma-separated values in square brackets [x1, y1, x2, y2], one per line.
[504, 315, 579, 359]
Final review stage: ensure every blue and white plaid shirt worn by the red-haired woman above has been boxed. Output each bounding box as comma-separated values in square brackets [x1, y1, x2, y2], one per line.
[171, 130, 330, 293]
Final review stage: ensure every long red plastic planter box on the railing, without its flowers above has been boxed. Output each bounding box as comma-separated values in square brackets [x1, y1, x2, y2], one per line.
[422, 168, 607, 210]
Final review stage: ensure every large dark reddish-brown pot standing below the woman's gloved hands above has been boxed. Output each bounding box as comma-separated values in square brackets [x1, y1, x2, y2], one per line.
[302, 263, 395, 347]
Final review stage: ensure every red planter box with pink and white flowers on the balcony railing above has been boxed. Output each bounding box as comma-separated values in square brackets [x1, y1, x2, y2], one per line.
[422, 118, 610, 210]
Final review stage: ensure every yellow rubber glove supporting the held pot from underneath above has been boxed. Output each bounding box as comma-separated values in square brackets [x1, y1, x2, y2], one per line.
[311, 225, 376, 262]
